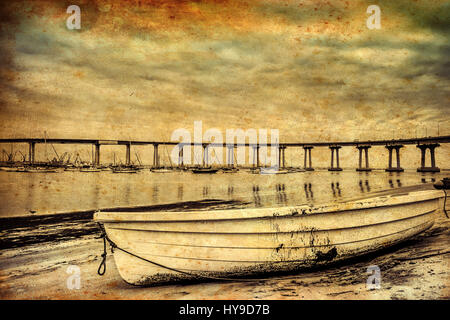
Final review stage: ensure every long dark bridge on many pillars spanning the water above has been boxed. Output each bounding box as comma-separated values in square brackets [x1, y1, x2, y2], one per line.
[0, 136, 450, 172]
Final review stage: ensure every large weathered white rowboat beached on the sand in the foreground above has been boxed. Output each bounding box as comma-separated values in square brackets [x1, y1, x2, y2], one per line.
[95, 191, 440, 285]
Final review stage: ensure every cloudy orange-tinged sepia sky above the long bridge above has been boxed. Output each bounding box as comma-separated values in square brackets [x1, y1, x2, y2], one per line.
[0, 0, 450, 146]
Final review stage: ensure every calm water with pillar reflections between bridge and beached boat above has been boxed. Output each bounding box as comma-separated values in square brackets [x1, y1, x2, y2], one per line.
[0, 170, 448, 217]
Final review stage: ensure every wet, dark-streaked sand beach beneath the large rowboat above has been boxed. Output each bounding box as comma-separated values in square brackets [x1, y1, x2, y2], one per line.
[0, 186, 450, 300]
